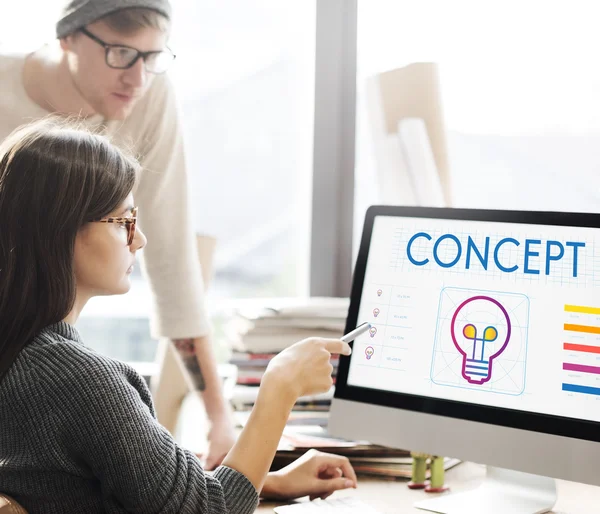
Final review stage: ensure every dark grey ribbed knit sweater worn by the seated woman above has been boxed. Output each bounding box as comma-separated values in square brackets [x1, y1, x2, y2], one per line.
[0, 322, 258, 514]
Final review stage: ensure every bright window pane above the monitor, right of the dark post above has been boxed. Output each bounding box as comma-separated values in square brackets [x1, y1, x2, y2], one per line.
[356, 0, 600, 242]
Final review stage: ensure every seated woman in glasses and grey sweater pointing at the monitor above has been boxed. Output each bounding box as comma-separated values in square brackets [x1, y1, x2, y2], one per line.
[0, 120, 356, 514]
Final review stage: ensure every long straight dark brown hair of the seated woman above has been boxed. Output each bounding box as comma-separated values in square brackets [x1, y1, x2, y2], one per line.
[0, 117, 139, 380]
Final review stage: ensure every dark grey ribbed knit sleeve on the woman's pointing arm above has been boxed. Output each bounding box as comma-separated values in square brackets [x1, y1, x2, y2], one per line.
[52, 355, 258, 514]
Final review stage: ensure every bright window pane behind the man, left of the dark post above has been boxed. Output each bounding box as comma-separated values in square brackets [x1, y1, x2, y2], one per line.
[0, 0, 316, 361]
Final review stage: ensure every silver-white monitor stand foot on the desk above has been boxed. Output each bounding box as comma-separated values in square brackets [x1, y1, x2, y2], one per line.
[415, 466, 556, 514]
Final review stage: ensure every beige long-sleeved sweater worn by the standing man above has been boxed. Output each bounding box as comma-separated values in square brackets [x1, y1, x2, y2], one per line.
[0, 54, 209, 339]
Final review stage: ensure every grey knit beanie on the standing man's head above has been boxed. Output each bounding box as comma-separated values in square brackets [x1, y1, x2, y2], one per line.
[56, 0, 171, 39]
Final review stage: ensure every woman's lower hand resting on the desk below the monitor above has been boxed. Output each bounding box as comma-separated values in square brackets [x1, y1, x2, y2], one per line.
[261, 450, 357, 500]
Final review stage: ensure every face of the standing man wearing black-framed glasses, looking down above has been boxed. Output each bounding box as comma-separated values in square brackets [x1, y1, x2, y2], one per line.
[61, 21, 167, 120]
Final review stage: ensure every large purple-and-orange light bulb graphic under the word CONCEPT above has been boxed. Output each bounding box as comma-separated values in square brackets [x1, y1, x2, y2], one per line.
[450, 296, 511, 385]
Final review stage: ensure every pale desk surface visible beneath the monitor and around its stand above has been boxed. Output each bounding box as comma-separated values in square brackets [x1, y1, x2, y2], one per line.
[256, 462, 600, 514]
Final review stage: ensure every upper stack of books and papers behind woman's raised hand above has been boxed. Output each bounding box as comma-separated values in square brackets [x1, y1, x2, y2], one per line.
[227, 297, 349, 411]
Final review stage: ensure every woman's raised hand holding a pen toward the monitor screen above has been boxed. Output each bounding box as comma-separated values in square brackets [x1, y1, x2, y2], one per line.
[261, 337, 352, 402]
